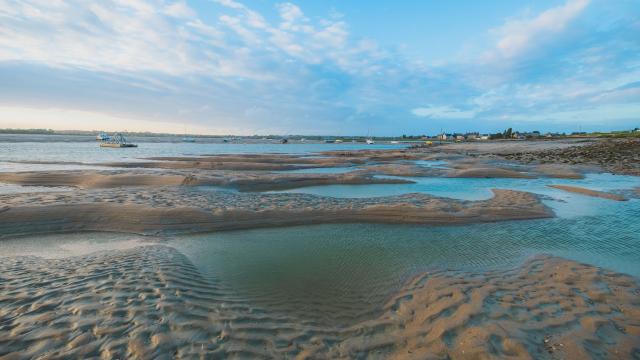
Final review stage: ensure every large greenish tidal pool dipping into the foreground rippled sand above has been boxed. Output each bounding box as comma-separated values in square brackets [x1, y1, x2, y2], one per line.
[2, 204, 640, 326]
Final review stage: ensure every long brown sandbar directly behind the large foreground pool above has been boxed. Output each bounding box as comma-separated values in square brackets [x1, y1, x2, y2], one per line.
[0, 187, 553, 237]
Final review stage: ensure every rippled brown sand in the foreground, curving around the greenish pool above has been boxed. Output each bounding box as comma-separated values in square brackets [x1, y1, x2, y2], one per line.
[0, 245, 640, 359]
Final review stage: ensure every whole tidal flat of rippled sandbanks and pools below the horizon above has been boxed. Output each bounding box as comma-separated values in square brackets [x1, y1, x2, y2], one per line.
[0, 136, 640, 359]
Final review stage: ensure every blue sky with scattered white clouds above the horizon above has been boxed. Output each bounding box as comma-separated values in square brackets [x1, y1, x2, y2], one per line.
[0, 0, 640, 135]
